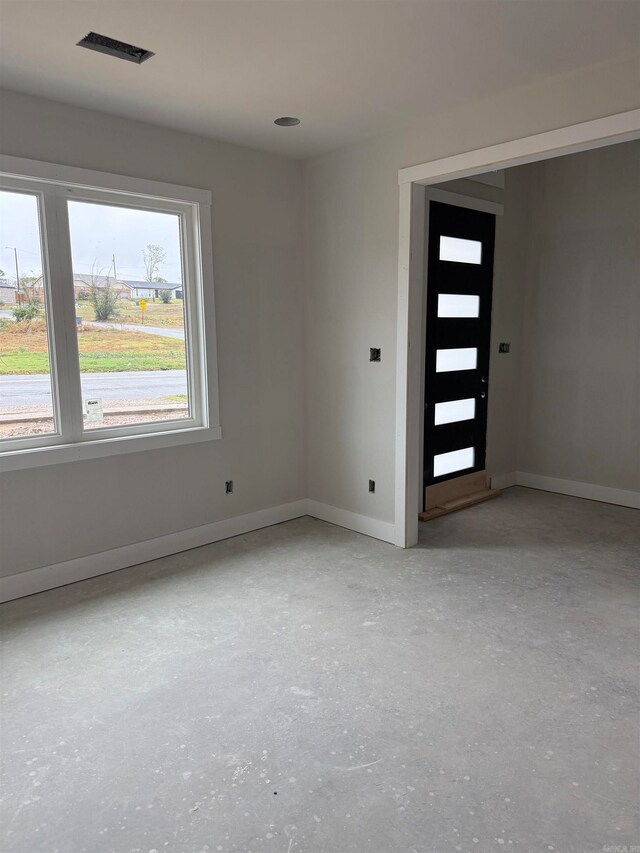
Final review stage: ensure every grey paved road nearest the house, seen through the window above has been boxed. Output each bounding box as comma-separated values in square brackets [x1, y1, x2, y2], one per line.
[0, 370, 187, 409]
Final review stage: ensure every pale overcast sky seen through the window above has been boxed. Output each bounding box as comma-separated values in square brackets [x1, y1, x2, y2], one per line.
[0, 191, 182, 283]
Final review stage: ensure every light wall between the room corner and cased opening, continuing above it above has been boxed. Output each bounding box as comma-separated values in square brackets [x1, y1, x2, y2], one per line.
[305, 59, 640, 521]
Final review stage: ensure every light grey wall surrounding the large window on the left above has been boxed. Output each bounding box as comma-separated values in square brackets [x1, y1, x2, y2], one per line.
[0, 92, 305, 575]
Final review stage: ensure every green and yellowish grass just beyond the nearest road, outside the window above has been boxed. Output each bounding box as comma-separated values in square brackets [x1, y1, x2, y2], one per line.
[0, 320, 185, 376]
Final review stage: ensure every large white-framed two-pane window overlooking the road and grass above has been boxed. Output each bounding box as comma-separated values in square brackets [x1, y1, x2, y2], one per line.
[0, 158, 219, 467]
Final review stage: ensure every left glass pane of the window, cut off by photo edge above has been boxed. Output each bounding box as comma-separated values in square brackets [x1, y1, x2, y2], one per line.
[0, 190, 55, 439]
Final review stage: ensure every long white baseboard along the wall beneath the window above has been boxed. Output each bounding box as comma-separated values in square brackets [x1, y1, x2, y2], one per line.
[0, 500, 308, 602]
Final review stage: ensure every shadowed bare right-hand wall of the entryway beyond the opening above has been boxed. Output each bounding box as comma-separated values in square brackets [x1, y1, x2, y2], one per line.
[514, 142, 640, 491]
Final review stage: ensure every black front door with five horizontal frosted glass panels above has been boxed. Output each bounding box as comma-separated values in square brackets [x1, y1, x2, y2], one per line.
[424, 201, 495, 486]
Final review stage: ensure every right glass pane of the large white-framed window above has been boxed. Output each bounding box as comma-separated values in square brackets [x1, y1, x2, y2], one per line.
[68, 201, 190, 429]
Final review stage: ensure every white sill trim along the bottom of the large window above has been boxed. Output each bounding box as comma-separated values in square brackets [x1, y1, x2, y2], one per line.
[0, 426, 222, 472]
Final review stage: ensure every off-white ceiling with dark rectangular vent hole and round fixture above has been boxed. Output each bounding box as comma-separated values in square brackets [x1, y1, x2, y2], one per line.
[0, 0, 640, 157]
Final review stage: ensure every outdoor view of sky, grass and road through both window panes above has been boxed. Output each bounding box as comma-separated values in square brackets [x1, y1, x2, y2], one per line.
[0, 191, 193, 439]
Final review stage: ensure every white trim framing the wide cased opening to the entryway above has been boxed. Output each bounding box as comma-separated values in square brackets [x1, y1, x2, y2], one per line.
[394, 109, 640, 548]
